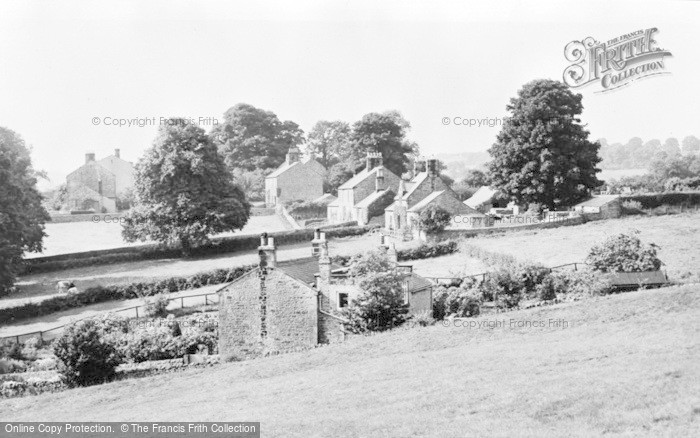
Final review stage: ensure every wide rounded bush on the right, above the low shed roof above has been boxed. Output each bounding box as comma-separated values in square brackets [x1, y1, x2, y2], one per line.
[586, 231, 661, 272]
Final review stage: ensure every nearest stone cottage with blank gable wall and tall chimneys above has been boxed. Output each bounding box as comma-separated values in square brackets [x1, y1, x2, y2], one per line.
[219, 230, 433, 359]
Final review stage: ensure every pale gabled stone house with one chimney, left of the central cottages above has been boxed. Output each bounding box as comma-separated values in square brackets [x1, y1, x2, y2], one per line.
[265, 147, 326, 208]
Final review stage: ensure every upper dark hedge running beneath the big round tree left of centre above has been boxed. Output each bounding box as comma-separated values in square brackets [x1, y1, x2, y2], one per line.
[20, 227, 370, 275]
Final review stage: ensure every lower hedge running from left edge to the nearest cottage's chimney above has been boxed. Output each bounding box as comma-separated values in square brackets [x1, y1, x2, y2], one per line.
[0, 265, 256, 322]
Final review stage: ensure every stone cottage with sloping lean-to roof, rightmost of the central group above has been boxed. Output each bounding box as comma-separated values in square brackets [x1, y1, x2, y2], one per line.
[384, 158, 483, 238]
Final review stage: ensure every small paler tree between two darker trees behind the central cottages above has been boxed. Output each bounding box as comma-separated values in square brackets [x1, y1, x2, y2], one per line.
[306, 120, 353, 169]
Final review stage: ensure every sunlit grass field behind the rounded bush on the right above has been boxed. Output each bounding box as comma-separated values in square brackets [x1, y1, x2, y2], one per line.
[467, 213, 700, 282]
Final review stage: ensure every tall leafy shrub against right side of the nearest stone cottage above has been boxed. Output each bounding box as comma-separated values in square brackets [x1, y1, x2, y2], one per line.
[343, 271, 408, 333]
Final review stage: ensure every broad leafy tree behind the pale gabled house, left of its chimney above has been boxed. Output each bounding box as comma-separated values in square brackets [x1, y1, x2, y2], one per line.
[212, 103, 304, 170]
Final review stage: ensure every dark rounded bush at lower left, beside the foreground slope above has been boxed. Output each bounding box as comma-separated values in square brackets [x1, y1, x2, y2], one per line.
[54, 319, 120, 385]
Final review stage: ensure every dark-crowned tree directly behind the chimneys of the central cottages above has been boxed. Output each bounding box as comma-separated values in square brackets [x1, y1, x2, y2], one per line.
[346, 111, 417, 175]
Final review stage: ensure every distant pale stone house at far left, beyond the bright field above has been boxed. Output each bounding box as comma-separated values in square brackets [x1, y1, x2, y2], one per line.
[66, 149, 135, 213]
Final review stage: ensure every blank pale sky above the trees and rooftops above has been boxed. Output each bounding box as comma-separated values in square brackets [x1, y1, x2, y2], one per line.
[0, 0, 700, 188]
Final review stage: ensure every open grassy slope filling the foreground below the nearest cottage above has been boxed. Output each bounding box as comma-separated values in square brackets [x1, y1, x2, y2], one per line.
[0, 285, 700, 436]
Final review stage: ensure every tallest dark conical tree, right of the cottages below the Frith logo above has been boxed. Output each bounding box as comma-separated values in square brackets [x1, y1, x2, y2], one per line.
[488, 80, 601, 209]
